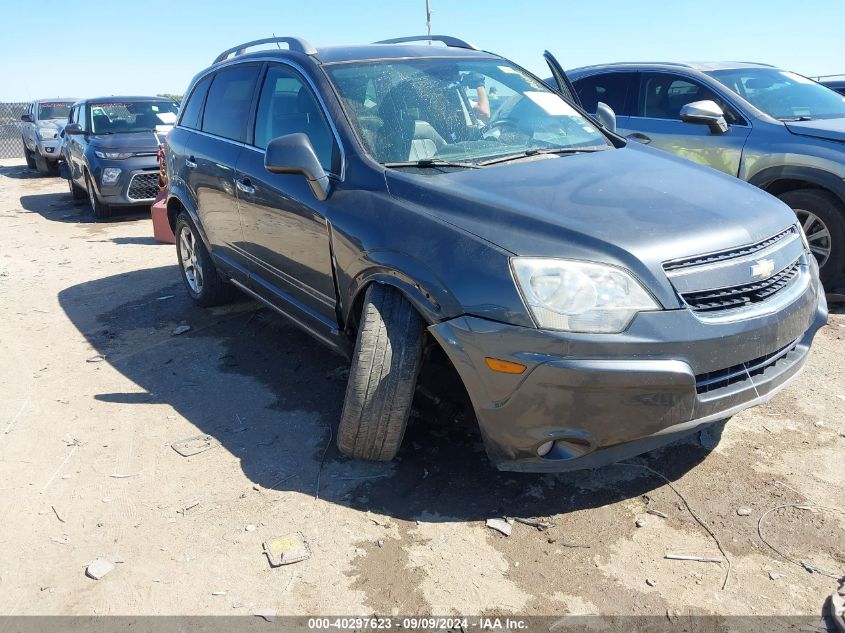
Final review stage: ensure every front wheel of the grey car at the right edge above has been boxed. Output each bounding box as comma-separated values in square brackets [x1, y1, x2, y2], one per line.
[778, 189, 845, 285]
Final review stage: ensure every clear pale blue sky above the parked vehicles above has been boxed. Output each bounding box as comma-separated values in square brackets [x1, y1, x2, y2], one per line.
[0, 0, 845, 101]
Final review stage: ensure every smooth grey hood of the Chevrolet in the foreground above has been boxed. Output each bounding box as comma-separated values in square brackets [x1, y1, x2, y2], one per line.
[386, 143, 795, 275]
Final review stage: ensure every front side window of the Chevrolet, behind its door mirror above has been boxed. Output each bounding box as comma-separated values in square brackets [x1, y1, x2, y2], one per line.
[252, 65, 334, 171]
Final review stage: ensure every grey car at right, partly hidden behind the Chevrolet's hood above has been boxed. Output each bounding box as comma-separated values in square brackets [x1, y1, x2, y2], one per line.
[568, 62, 845, 285]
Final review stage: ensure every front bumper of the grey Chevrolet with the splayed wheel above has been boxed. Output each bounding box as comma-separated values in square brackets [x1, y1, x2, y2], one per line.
[429, 275, 827, 472]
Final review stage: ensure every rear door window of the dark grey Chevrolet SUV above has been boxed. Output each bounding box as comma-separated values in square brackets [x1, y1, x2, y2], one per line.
[202, 64, 259, 141]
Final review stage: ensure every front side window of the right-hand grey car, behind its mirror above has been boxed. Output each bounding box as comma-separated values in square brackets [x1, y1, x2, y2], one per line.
[636, 73, 745, 124]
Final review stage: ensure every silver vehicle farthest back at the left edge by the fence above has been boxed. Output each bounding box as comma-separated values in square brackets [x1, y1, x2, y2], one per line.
[21, 98, 76, 174]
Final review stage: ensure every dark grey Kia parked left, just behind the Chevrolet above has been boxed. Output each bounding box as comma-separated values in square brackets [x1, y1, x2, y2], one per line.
[62, 97, 179, 218]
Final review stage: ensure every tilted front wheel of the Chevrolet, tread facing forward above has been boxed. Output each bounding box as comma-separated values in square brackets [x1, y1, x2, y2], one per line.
[337, 284, 424, 462]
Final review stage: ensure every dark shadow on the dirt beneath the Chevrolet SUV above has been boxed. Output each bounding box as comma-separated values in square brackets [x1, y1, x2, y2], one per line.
[59, 265, 718, 521]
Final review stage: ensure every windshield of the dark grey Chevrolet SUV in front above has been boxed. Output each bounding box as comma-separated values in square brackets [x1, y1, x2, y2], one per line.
[328, 58, 610, 166]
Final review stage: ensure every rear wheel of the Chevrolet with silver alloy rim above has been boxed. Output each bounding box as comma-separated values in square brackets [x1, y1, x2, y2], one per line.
[176, 212, 233, 307]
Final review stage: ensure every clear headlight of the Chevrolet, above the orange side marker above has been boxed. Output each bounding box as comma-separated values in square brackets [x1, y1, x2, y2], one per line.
[511, 257, 660, 333]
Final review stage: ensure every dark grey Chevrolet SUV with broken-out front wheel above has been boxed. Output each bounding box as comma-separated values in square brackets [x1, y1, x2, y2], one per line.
[166, 37, 827, 471]
